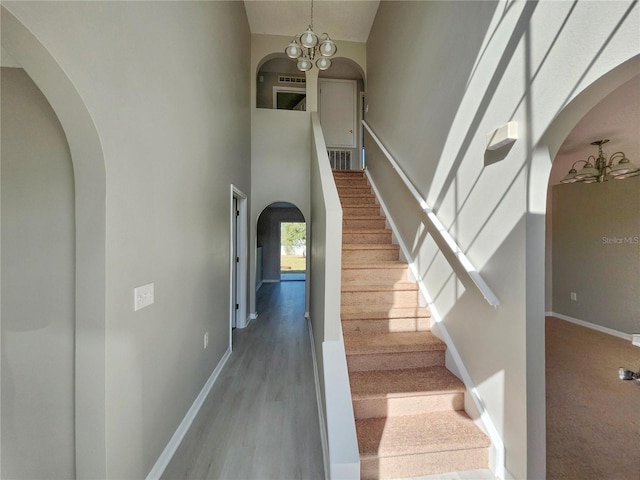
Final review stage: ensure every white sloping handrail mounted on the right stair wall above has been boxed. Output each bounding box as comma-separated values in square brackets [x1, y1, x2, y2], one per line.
[362, 120, 500, 307]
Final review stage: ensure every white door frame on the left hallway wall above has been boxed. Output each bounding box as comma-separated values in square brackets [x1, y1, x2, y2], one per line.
[229, 184, 248, 350]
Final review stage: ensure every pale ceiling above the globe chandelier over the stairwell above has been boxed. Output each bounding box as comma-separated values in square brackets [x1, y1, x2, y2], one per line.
[244, 0, 380, 43]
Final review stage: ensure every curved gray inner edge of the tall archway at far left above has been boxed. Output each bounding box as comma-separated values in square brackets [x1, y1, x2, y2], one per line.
[1, 6, 106, 478]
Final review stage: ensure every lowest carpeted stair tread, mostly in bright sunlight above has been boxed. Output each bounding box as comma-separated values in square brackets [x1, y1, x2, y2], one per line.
[356, 411, 490, 460]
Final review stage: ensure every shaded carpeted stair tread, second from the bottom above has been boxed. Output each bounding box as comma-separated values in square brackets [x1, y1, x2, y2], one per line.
[349, 366, 465, 400]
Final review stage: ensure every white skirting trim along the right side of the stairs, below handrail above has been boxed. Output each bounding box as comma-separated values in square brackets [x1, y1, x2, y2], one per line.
[365, 170, 508, 480]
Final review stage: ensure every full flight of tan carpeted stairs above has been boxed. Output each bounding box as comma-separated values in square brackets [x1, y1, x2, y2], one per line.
[334, 171, 490, 479]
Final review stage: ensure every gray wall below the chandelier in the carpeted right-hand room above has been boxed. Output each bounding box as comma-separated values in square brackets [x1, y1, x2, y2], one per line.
[552, 177, 640, 334]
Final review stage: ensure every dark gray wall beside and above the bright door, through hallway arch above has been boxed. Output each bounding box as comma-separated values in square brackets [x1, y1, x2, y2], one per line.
[257, 207, 305, 282]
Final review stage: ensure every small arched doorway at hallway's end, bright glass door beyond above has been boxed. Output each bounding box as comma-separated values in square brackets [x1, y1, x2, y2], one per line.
[256, 202, 307, 290]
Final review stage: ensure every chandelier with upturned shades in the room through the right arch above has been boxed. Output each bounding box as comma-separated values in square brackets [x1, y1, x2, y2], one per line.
[560, 139, 640, 183]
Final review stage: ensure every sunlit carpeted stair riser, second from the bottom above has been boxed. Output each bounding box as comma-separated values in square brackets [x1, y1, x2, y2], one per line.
[353, 392, 464, 419]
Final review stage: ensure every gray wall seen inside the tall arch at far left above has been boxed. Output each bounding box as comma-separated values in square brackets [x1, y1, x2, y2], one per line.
[0, 68, 75, 479]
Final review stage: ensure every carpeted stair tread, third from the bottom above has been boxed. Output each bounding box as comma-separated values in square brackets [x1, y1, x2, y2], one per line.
[344, 332, 447, 355]
